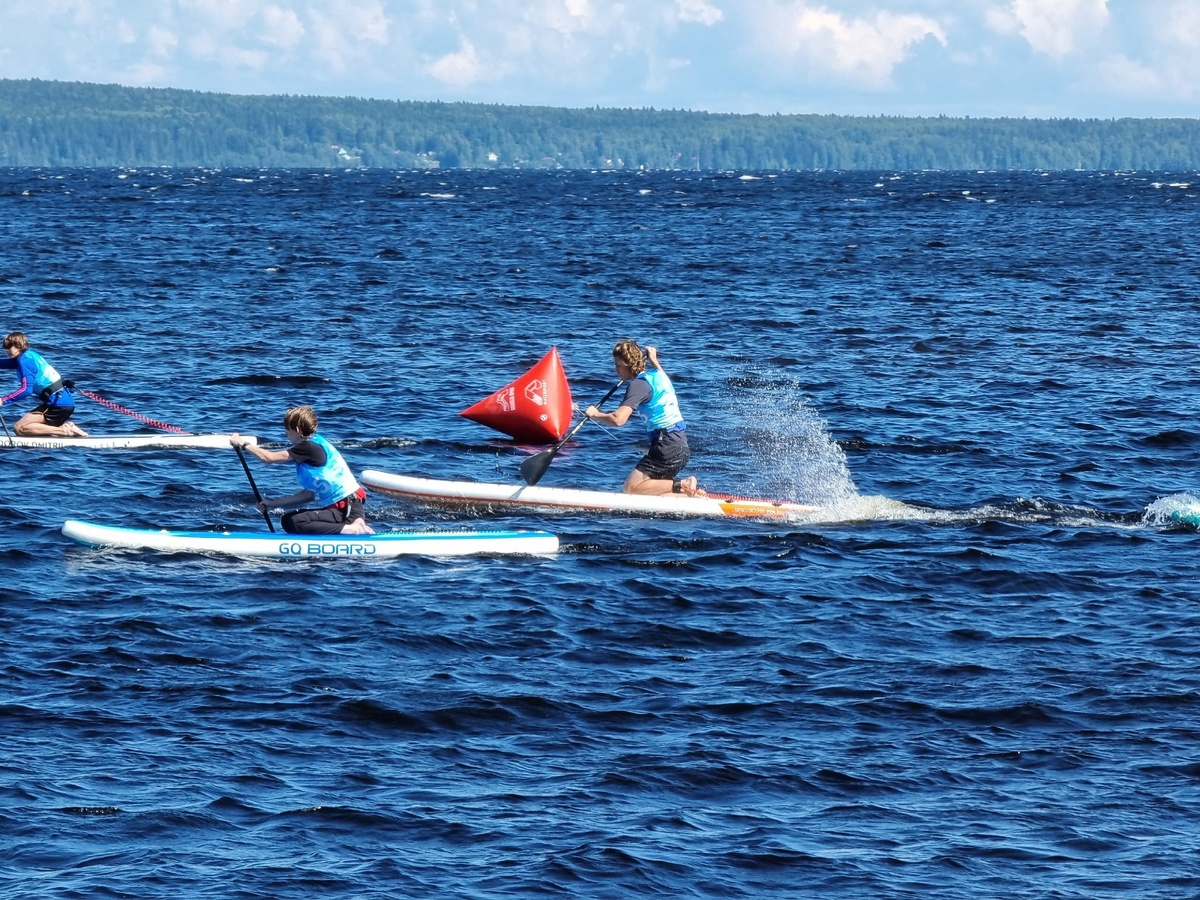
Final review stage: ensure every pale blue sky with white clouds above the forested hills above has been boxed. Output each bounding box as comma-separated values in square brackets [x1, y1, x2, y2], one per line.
[0, 0, 1200, 119]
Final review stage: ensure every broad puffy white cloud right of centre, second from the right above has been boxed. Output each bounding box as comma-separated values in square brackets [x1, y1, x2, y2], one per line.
[760, 0, 947, 89]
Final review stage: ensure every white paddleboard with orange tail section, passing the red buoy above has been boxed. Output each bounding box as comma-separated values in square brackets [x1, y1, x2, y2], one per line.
[361, 469, 821, 518]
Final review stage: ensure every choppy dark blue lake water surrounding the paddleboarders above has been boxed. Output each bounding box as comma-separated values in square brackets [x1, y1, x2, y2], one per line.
[0, 170, 1200, 898]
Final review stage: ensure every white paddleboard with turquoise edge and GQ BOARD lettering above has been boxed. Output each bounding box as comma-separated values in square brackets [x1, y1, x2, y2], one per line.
[62, 518, 558, 559]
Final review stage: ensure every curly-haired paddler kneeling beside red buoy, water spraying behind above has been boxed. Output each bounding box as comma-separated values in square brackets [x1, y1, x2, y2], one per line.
[583, 341, 704, 497]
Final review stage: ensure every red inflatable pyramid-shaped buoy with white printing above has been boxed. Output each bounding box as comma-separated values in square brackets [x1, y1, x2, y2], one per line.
[458, 347, 571, 444]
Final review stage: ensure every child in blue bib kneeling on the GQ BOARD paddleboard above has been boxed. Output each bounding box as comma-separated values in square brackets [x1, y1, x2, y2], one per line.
[229, 406, 374, 534]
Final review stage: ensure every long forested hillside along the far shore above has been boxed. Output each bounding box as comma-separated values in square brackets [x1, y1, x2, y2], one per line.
[0, 79, 1200, 170]
